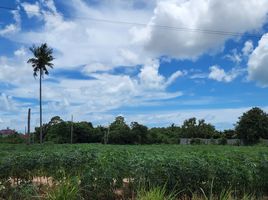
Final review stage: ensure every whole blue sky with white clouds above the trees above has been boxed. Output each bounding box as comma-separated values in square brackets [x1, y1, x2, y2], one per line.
[0, 0, 268, 132]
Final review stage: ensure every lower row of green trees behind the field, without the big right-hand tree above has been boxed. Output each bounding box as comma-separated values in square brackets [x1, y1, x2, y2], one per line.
[34, 116, 224, 144]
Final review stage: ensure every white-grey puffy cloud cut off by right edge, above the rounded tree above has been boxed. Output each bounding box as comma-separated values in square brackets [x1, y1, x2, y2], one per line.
[248, 33, 268, 87]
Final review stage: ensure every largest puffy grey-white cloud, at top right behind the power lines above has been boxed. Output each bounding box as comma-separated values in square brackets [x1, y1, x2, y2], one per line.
[132, 0, 268, 59]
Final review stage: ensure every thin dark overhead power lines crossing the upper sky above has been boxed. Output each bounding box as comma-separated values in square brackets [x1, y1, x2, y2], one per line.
[0, 6, 266, 38]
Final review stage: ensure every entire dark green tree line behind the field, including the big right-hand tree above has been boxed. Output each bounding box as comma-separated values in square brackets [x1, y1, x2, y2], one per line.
[27, 107, 268, 144]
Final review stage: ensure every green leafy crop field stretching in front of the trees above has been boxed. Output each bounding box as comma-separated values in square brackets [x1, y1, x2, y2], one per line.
[0, 144, 268, 199]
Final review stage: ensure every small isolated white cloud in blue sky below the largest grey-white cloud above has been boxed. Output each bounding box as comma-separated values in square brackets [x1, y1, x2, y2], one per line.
[208, 65, 243, 83]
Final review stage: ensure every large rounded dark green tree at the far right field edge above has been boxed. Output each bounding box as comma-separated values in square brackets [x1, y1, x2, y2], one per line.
[236, 107, 268, 144]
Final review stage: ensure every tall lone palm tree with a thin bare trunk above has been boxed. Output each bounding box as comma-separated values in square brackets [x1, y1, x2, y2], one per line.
[27, 43, 54, 144]
